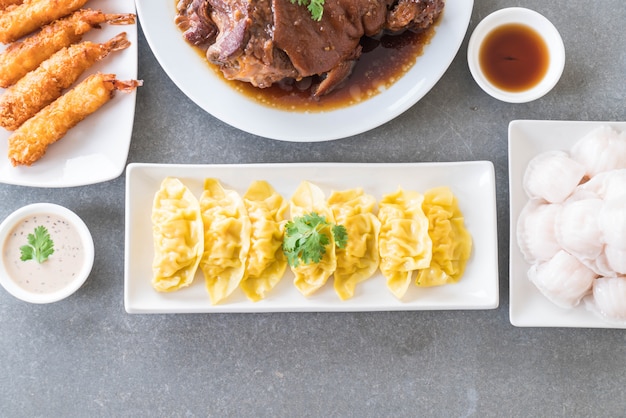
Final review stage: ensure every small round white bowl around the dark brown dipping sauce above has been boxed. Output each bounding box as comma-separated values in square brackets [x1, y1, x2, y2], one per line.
[467, 7, 565, 103]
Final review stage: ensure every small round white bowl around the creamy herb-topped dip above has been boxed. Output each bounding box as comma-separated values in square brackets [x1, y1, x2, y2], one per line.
[0, 203, 94, 304]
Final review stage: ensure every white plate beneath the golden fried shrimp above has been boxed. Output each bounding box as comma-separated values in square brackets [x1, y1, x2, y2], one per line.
[0, 0, 141, 187]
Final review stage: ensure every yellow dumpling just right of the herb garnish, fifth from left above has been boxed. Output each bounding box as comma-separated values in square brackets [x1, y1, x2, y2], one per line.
[328, 188, 380, 300]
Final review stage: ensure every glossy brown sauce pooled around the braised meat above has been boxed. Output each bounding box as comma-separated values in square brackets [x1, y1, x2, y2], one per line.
[196, 22, 436, 112]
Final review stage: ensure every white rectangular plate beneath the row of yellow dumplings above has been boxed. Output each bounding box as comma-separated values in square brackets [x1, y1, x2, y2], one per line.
[124, 161, 499, 313]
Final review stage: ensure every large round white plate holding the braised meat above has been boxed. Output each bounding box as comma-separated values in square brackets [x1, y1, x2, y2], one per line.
[136, 0, 474, 142]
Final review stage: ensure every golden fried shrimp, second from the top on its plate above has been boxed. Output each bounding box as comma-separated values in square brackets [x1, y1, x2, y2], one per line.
[0, 9, 135, 88]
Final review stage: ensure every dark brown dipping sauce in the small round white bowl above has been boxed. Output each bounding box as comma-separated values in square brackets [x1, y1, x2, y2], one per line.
[479, 23, 550, 92]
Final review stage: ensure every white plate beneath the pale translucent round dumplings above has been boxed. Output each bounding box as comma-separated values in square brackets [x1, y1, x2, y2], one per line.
[509, 120, 626, 328]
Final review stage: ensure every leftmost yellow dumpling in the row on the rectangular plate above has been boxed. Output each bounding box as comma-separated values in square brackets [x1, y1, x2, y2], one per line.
[152, 177, 204, 292]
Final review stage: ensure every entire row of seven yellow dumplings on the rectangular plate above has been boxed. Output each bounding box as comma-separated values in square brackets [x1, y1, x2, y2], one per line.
[152, 177, 472, 304]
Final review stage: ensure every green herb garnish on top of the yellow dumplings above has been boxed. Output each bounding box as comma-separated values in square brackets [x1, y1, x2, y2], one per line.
[283, 212, 348, 267]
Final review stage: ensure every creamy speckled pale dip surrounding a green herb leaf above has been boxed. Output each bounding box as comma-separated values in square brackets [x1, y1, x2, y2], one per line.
[2, 214, 85, 293]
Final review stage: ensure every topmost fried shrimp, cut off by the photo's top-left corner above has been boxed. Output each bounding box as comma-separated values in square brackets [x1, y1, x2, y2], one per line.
[0, 0, 87, 44]
